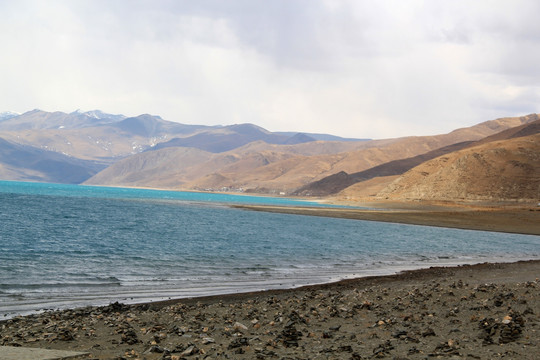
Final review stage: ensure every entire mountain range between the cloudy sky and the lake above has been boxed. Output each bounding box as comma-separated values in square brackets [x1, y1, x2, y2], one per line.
[0, 110, 540, 201]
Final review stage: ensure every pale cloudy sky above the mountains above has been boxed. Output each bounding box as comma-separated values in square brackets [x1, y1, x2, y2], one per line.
[0, 0, 540, 138]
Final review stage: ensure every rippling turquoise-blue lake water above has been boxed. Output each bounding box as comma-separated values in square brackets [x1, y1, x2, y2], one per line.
[0, 181, 540, 318]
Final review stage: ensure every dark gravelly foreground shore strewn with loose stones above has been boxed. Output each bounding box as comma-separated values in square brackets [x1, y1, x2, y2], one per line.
[0, 261, 540, 359]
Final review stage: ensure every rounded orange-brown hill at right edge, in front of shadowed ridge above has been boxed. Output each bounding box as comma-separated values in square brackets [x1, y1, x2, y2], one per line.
[378, 134, 540, 202]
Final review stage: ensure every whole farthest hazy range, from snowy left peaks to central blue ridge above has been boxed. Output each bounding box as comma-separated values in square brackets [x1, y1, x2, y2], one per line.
[0, 109, 320, 163]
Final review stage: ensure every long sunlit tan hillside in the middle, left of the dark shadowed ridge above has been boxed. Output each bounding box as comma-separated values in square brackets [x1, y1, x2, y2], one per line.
[83, 115, 538, 193]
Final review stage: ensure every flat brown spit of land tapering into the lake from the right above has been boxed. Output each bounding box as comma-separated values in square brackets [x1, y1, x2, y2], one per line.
[230, 203, 540, 235]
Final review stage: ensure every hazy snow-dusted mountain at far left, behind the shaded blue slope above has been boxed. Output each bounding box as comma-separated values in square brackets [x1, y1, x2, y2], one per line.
[0, 110, 212, 163]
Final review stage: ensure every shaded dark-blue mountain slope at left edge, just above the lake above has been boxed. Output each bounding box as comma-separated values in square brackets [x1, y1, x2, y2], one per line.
[0, 138, 105, 184]
